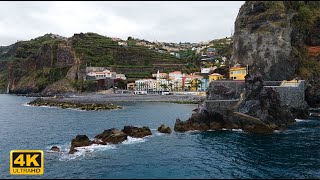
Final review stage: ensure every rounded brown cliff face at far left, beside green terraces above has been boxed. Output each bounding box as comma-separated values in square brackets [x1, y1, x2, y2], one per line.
[0, 35, 78, 94]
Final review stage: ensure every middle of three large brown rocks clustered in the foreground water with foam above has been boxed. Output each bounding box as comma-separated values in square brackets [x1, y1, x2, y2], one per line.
[95, 128, 127, 144]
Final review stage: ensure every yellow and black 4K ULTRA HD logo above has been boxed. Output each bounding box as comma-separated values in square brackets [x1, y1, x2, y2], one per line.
[10, 150, 44, 175]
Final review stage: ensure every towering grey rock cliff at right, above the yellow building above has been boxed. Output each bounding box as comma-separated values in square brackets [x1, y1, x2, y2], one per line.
[230, 1, 320, 106]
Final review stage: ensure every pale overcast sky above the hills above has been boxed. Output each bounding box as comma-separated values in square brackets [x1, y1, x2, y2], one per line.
[0, 1, 244, 45]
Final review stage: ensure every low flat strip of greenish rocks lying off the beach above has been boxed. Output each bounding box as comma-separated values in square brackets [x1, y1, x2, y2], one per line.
[28, 98, 121, 111]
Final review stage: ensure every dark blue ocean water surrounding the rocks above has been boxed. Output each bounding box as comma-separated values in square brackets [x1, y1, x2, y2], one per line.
[0, 95, 320, 179]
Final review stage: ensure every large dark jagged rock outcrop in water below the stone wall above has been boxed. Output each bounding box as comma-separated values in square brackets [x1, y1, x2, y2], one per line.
[174, 74, 302, 133]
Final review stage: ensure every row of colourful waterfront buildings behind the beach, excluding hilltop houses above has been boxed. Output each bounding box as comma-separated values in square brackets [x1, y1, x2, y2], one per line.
[84, 64, 248, 95]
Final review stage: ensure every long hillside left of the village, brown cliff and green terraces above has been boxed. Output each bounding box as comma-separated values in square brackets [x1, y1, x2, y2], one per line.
[0, 33, 188, 94]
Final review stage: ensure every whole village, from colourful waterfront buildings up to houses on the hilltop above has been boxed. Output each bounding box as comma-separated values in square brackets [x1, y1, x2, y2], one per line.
[80, 37, 248, 95]
